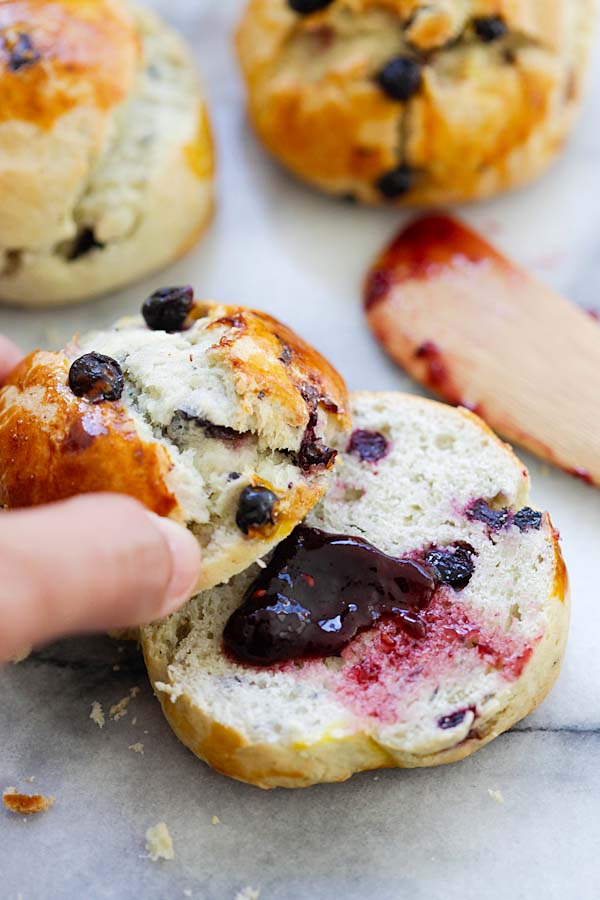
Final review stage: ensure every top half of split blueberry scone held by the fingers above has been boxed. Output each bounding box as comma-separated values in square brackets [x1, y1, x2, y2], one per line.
[0, 288, 350, 588]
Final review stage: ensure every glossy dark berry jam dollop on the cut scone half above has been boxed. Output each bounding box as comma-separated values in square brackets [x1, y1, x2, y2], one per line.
[223, 525, 452, 665]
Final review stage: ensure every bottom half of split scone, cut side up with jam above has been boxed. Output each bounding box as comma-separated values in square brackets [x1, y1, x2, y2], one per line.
[143, 393, 569, 788]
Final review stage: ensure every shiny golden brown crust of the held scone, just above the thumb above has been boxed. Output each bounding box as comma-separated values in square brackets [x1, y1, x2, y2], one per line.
[0, 351, 177, 516]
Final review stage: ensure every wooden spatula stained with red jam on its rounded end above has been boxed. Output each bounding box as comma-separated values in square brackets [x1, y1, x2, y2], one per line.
[365, 216, 600, 487]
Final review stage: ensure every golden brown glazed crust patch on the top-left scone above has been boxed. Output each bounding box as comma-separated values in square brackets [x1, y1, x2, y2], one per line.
[0, 0, 140, 128]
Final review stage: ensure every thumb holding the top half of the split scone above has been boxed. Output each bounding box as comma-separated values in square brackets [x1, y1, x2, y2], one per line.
[0, 494, 200, 660]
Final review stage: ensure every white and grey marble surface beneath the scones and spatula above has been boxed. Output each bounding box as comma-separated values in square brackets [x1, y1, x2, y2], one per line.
[0, 0, 600, 900]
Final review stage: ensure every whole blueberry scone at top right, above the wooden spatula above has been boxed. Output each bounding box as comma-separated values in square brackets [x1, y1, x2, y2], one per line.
[237, 0, 594, 205]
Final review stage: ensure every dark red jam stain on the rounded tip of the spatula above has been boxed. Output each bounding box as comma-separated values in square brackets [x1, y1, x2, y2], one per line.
[364, 215, 510, 311]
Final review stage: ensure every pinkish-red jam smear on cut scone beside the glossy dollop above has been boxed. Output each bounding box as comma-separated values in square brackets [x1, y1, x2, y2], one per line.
[333, 591, 535, 724]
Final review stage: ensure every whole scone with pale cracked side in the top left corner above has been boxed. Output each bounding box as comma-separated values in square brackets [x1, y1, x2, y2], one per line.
[0, 0, 213, 306]
